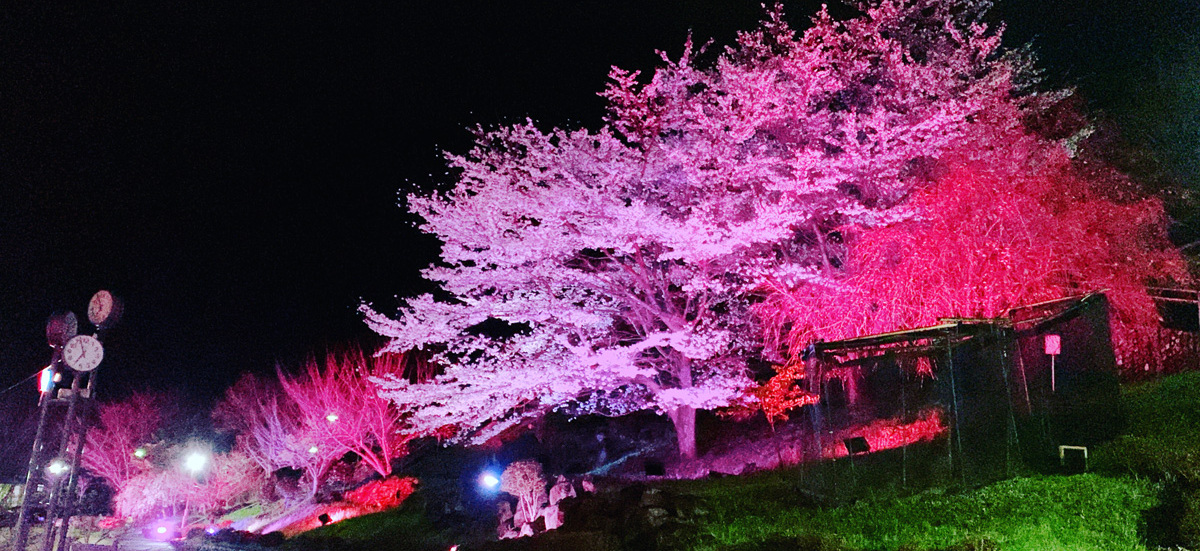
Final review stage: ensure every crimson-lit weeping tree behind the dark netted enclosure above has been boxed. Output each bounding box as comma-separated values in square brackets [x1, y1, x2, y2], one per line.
[757, 115, 1189, 379]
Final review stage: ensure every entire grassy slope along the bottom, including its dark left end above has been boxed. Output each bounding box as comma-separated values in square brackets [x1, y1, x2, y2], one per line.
[289, 373, 1200, 551]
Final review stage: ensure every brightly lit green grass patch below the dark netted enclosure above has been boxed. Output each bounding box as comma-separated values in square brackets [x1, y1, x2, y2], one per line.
[683, 474, 1158, 550]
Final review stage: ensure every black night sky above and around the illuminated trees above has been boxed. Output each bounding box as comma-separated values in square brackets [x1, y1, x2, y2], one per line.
[0, 0, 1200, 403]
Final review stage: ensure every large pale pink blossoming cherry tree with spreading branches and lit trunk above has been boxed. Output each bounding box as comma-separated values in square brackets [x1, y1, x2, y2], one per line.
[364, 0, 1033, 457]
